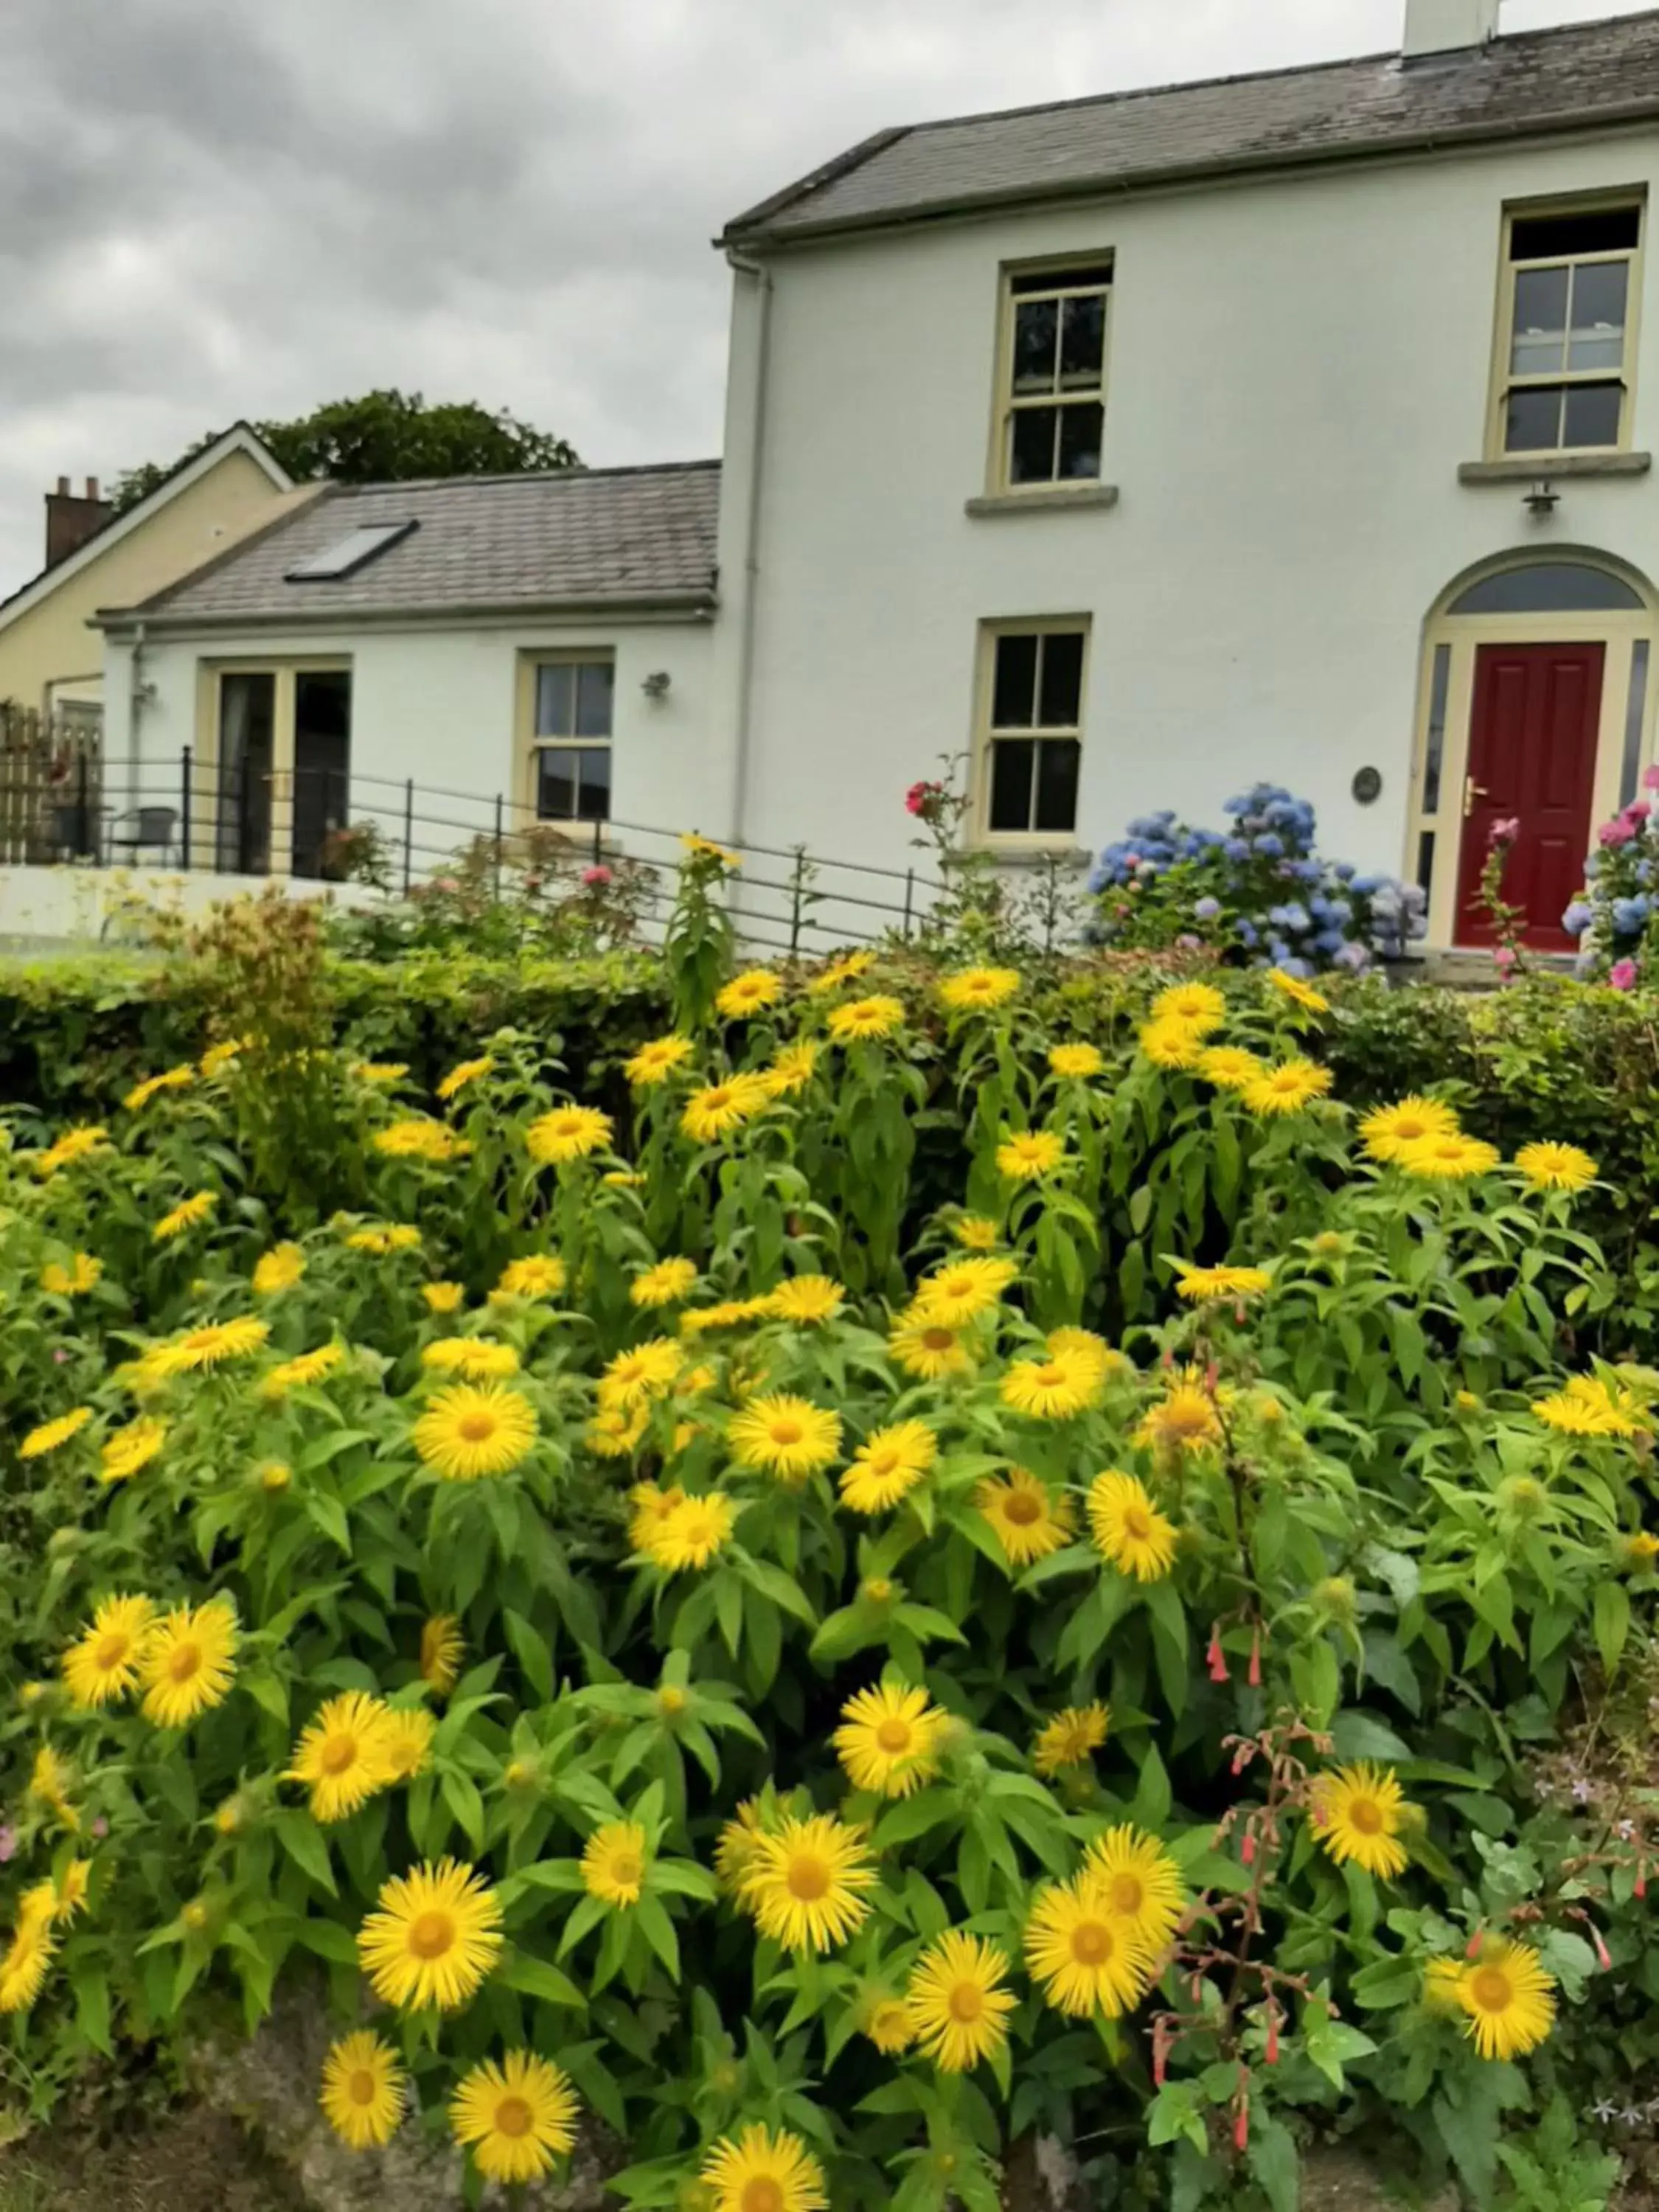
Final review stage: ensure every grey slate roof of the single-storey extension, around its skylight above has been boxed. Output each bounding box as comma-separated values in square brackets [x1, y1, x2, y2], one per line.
[100, 460, 719, 626]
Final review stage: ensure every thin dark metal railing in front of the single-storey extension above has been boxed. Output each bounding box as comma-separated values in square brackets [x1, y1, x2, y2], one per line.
[0, 745, 1022, 956]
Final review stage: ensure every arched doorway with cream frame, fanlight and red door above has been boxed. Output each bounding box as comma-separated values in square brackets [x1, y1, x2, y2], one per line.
[1407, 546, 1659, 951]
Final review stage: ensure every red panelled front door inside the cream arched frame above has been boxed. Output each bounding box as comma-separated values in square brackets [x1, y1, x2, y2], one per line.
[1455, 646, 1606, 953]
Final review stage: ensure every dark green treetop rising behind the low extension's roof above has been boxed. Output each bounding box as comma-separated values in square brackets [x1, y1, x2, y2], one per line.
[113, 392, 582, 513]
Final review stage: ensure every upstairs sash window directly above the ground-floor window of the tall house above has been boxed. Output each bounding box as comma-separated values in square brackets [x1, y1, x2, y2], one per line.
[991, 257, 1113, 491]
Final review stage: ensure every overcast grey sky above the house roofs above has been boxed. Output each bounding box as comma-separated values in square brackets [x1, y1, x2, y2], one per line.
[0, 0, 1639, 593]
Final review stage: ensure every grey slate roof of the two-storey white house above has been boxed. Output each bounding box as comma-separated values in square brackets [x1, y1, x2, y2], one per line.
[723, 9, 1659, 243]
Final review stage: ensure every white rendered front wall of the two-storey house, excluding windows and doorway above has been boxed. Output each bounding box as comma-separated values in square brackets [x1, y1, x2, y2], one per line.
[717, 131, 1659, 898]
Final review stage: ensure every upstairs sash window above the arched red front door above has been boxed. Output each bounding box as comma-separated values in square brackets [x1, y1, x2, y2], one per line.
[1489, 195, 1646, 458]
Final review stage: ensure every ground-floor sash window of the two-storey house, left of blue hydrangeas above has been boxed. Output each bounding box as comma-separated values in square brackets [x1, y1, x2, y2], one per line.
[975, 619, 1088, 847]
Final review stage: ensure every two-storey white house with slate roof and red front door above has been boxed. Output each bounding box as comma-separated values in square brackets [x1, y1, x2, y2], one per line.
[712, 0, 1659, 947]
